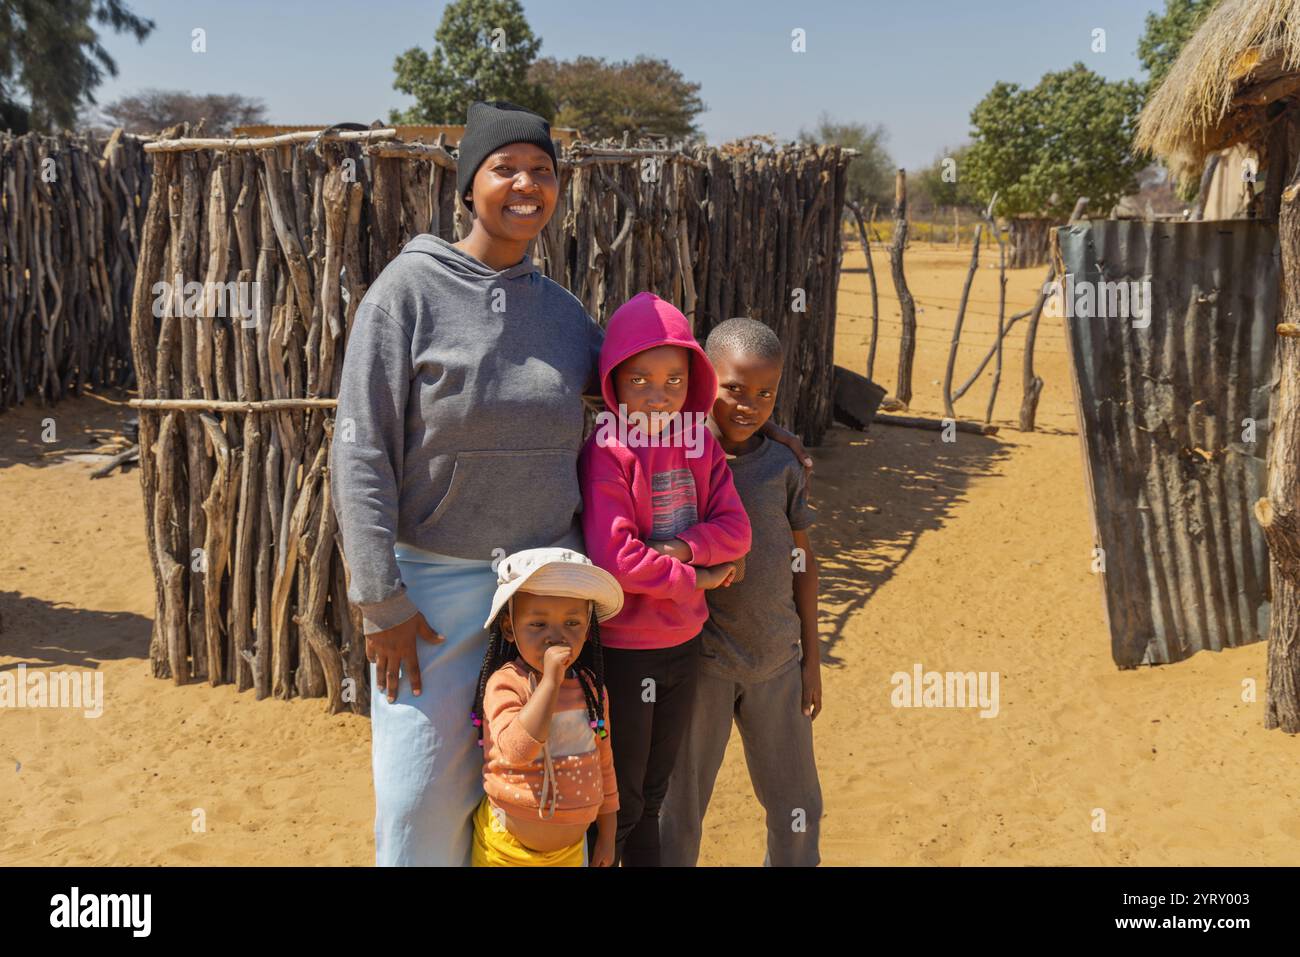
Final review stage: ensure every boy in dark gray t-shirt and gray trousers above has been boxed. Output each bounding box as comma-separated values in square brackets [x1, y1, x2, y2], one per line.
[660, 319, 822, 867]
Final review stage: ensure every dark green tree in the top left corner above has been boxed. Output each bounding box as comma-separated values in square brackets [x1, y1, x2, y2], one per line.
[0, 0, 153, 133]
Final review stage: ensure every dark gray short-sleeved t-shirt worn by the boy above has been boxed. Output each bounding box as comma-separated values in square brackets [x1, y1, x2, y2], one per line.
[699, 437, 814, 683]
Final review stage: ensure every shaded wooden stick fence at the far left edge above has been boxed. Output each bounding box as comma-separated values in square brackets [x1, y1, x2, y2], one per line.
[0, 131, 150, 411]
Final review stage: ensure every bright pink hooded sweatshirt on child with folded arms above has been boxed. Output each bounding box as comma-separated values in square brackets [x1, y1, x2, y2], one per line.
[579, 293, 750, 649]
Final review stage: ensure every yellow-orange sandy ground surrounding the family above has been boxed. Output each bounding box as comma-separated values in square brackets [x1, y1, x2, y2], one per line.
[0, 244, 1300, 865]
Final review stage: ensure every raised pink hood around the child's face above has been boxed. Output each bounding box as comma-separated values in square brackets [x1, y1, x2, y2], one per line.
[601, 293, 718, 412]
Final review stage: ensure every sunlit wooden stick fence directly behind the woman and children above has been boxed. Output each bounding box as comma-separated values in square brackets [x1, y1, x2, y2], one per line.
[131, 130, 850, 713]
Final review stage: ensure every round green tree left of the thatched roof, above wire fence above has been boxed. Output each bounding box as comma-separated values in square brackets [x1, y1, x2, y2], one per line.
[965, 64, 1144, 220]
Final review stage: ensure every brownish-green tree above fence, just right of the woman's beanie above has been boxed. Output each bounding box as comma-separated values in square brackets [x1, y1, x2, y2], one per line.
[529, 56, 705, 140]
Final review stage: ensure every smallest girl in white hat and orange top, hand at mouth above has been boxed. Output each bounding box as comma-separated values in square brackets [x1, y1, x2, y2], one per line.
[471, 547, 623, 867]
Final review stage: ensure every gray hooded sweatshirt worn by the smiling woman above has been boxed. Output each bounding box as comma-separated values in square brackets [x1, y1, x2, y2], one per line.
[330, 234, 605, 635]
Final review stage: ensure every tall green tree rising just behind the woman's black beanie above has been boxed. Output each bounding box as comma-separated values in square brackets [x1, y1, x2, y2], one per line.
[389, 0, 555, 124]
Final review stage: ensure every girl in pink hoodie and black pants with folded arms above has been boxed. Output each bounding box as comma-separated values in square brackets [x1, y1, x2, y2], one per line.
[579, 293, 750, 866]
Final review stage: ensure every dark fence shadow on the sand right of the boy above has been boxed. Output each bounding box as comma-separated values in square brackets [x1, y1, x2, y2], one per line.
[813, 424, 1010, 664]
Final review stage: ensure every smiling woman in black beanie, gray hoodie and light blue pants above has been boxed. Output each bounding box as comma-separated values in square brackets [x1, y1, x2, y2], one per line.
[330, 101, 810, 866]
